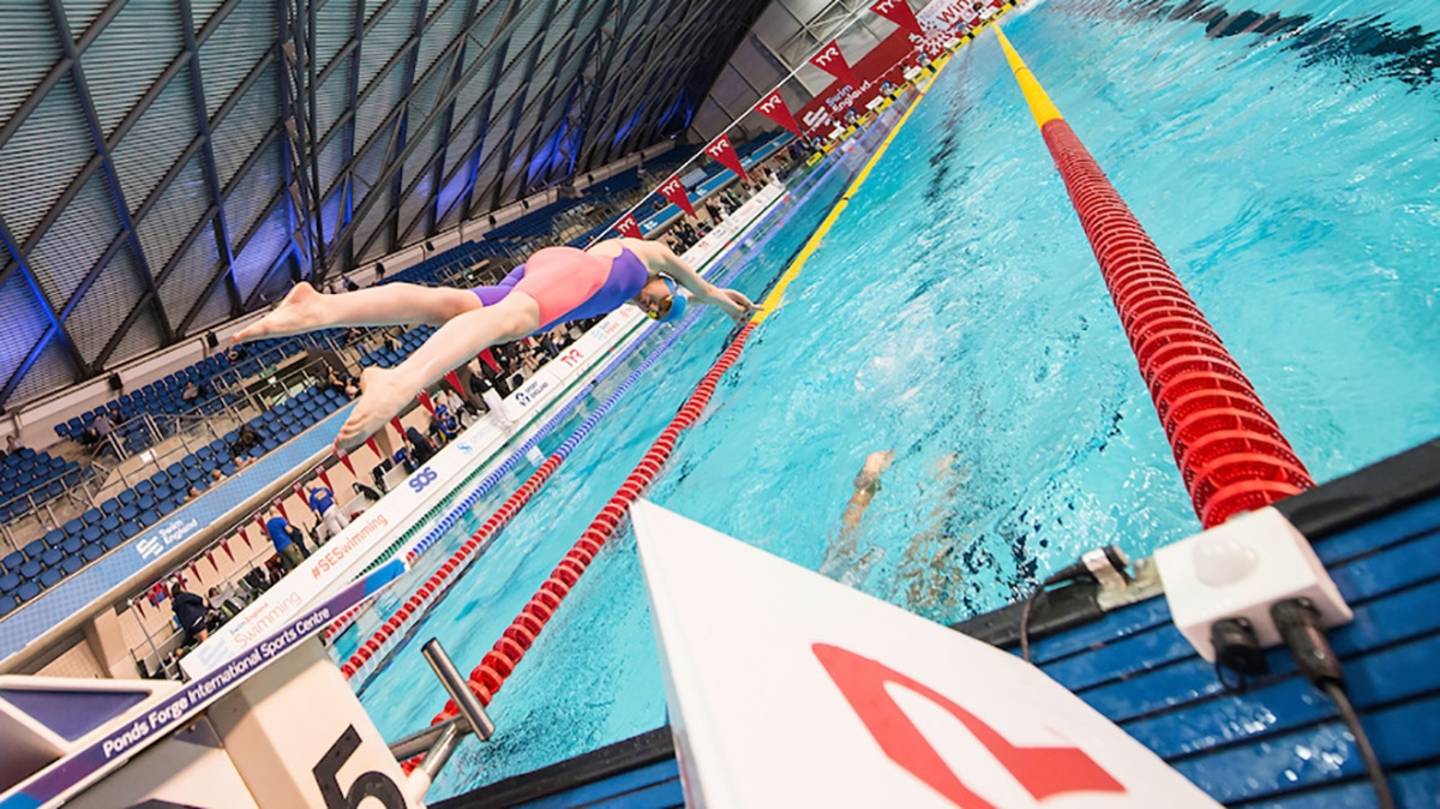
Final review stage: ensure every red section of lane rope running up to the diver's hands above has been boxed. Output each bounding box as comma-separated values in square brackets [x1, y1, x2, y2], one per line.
[403, 321, 755, 773]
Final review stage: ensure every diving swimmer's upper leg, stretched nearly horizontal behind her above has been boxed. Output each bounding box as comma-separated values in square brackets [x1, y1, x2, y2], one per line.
[232, 281, 481, 343]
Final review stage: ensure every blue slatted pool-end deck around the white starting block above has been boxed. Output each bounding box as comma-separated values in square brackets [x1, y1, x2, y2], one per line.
[438, 440, 1440, 809]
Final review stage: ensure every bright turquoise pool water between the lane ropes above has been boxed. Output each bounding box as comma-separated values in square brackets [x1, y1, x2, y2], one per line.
[361, 0, 1440, 797]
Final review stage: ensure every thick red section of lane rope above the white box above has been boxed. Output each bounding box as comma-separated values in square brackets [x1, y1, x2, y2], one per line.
[1040, 118, 1315, 528]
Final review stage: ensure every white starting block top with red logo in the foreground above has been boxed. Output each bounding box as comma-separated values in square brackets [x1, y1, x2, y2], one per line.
[631, 501, 1218, 809]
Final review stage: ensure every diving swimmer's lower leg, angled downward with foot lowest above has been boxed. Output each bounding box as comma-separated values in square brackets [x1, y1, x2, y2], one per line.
[336, 291, 540, 446]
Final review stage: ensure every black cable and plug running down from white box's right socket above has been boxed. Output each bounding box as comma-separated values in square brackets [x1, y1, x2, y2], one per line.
[1270, 599, 1395, 809]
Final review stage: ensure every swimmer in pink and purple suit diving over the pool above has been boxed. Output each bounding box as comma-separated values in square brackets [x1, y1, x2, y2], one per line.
[233, 239, 755, 446]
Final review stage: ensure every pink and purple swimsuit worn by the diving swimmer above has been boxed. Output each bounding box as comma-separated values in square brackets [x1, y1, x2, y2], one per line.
[472, 248, 649, 334]
